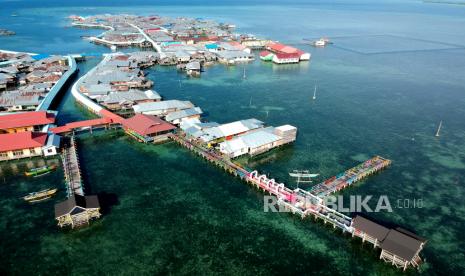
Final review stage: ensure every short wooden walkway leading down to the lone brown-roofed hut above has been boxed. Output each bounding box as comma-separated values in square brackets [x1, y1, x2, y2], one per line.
[62, 136, 84, 197]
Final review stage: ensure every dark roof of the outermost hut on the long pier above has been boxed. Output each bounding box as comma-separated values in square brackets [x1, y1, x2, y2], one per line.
[381, 229, 424, 261]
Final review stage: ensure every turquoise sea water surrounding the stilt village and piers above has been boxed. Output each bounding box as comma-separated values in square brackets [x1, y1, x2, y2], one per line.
[0, 1, 465, 275]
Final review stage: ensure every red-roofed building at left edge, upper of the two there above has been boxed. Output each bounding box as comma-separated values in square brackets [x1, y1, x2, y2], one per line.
[0, 111, 55, 134]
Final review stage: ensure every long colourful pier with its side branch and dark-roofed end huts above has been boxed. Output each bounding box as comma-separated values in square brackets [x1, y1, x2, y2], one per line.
[169, 132, 426, 270]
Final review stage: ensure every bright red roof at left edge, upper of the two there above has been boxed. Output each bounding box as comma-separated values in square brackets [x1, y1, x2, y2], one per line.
[0, 111, 55, 129]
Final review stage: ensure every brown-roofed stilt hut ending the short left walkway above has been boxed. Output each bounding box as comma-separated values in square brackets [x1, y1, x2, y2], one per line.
[55, 194, 101, 228]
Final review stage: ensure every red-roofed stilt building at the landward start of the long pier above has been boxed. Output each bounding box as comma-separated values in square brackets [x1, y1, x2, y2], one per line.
[121, 113, 176, 143]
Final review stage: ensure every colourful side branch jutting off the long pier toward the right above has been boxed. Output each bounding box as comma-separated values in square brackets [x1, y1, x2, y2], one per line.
[310, 156, 391, 198]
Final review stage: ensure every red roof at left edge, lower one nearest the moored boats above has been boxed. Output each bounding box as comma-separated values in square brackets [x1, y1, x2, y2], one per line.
[0, 131, 47, 152]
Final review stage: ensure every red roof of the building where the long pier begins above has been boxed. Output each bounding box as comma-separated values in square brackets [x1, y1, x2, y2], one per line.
[121, 113, 176, 136]
